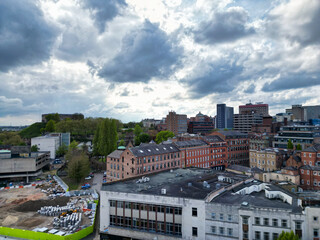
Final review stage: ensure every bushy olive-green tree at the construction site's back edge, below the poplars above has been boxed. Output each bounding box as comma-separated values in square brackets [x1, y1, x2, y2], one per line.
[67, 149, 90, 182]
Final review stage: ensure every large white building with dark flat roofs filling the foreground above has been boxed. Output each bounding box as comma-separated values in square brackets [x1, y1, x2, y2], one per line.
[100, 168, 320, 240]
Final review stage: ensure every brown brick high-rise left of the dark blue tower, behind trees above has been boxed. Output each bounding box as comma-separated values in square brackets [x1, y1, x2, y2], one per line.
[166, 111, 188, 135]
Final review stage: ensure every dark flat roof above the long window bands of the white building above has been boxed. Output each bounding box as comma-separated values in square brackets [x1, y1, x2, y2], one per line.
[101, 168, 248, 199]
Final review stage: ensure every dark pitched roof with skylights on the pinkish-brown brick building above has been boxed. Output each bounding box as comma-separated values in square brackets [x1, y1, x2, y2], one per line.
[129, 143, 180, 157]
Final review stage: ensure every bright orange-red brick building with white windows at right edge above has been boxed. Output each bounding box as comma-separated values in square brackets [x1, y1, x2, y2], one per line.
[299, 144, 320, 190]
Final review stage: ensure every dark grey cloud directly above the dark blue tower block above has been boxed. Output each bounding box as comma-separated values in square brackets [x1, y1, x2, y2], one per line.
[186, 61, 243, 98]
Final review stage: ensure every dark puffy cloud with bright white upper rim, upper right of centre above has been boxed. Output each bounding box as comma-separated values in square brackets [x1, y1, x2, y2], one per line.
[193, 8, 255, 44]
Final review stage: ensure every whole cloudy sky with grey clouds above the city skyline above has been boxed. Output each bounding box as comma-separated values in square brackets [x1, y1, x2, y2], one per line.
[0, 0, 320, 125]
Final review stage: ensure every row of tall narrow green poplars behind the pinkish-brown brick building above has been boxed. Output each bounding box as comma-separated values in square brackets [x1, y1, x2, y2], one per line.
[93, 118, 118, 156]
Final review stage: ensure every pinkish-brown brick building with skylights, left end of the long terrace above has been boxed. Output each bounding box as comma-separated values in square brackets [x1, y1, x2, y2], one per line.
[106, 144, 183, 181]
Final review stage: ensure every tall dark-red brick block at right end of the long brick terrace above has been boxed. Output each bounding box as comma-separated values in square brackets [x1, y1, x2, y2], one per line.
[209, 131, 249, 166]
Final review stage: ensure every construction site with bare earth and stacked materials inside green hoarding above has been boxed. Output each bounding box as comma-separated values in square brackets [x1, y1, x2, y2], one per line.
[0, 179, 96, 236]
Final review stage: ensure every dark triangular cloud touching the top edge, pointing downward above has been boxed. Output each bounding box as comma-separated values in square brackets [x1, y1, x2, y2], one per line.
[83, 0, 127, 33]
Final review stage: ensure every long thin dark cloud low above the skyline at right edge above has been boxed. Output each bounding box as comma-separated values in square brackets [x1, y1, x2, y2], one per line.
[262, 72, 320, 92]
